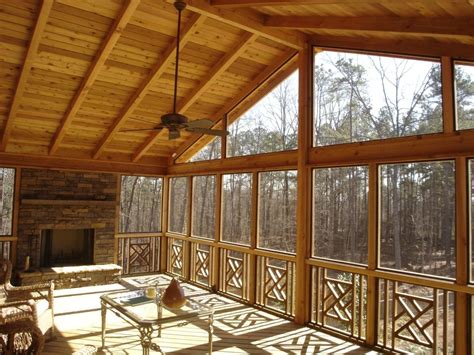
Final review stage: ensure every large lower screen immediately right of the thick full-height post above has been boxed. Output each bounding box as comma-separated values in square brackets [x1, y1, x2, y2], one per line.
[313, 166, 369, 264]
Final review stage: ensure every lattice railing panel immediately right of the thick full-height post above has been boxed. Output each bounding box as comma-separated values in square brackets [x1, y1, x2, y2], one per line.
[312, 266, 367, 339]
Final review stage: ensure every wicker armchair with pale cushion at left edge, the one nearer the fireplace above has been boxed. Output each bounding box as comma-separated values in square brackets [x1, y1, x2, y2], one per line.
[0, 260, 54, 338]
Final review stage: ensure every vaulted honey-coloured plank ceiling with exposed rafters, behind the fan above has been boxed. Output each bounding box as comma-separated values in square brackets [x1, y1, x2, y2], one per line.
[0, 0, 474, 172]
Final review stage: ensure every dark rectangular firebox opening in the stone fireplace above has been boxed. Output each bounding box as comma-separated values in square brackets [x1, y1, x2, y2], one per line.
[40, 229, 94, 267]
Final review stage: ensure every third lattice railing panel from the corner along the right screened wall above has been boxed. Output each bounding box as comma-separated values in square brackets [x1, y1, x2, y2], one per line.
[220, 249, 249, 300]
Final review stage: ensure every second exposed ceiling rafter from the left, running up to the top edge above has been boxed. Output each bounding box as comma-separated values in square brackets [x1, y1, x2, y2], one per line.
[49, 0, 140, 154]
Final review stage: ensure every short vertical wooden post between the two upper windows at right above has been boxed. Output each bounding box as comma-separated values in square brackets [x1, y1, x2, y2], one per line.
[441, 57, 456, 133]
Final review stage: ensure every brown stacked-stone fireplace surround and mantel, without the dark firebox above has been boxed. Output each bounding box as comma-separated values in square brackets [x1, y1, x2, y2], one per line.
[17, 169, 117, 269]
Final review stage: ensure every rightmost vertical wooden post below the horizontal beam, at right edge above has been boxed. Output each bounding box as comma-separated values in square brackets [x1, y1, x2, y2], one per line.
[454, 157, 470, 354]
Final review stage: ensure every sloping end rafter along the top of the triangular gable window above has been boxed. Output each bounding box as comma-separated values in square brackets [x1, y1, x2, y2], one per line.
[174, 50, 296, 163]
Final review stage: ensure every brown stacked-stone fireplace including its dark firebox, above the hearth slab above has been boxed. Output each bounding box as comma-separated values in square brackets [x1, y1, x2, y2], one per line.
[17, 169, 117, 269]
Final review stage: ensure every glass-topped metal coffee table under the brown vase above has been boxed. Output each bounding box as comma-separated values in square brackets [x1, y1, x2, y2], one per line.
[100, 288, 214, 354]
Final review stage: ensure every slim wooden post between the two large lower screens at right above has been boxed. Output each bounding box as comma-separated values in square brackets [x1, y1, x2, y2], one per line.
[366, 163, 379, 346]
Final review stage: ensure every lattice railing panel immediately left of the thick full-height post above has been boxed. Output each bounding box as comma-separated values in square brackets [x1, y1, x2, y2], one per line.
[257, 256, 295, 315]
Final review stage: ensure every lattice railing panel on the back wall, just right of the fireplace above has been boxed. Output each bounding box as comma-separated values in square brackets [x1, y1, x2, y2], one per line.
[118, 237, 160, 275]
